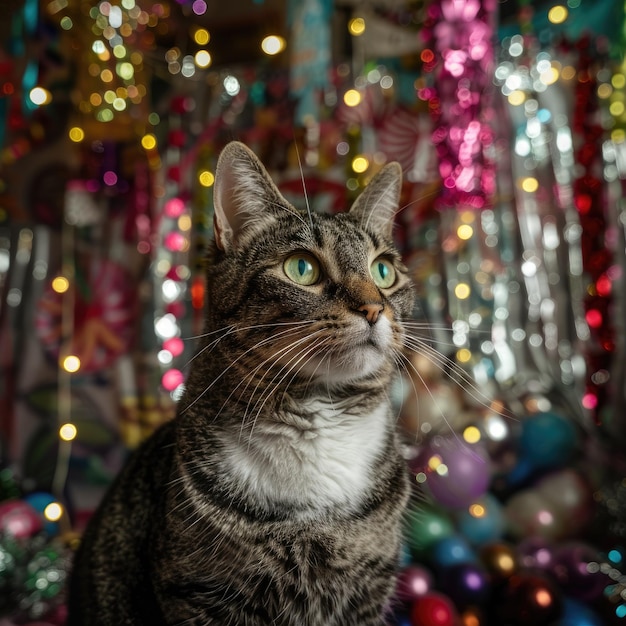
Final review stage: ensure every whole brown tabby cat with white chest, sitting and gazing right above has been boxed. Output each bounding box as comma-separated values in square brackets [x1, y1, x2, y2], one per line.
[69, 142, 414, 626]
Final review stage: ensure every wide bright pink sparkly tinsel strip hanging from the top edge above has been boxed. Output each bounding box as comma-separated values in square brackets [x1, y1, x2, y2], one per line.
[419, 0, 495, 209]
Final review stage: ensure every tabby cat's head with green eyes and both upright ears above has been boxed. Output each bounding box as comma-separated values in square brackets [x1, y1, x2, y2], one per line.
[202, 142, 413, 385]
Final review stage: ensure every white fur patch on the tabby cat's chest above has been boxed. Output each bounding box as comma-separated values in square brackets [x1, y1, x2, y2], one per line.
[217, 400, 388, 518]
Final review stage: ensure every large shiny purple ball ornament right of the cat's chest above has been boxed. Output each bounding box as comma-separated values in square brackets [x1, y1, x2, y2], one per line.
[411, 437, 491, 509]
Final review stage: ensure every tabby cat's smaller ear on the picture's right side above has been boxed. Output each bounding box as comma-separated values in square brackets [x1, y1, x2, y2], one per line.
[350, 161, 402, 238]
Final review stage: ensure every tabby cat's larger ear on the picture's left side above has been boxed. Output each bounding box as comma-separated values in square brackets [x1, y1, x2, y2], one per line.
[213, 141, 289, 251]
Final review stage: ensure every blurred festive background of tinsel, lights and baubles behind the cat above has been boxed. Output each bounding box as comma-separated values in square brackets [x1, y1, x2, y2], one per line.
[0, 0, 626, 626]
